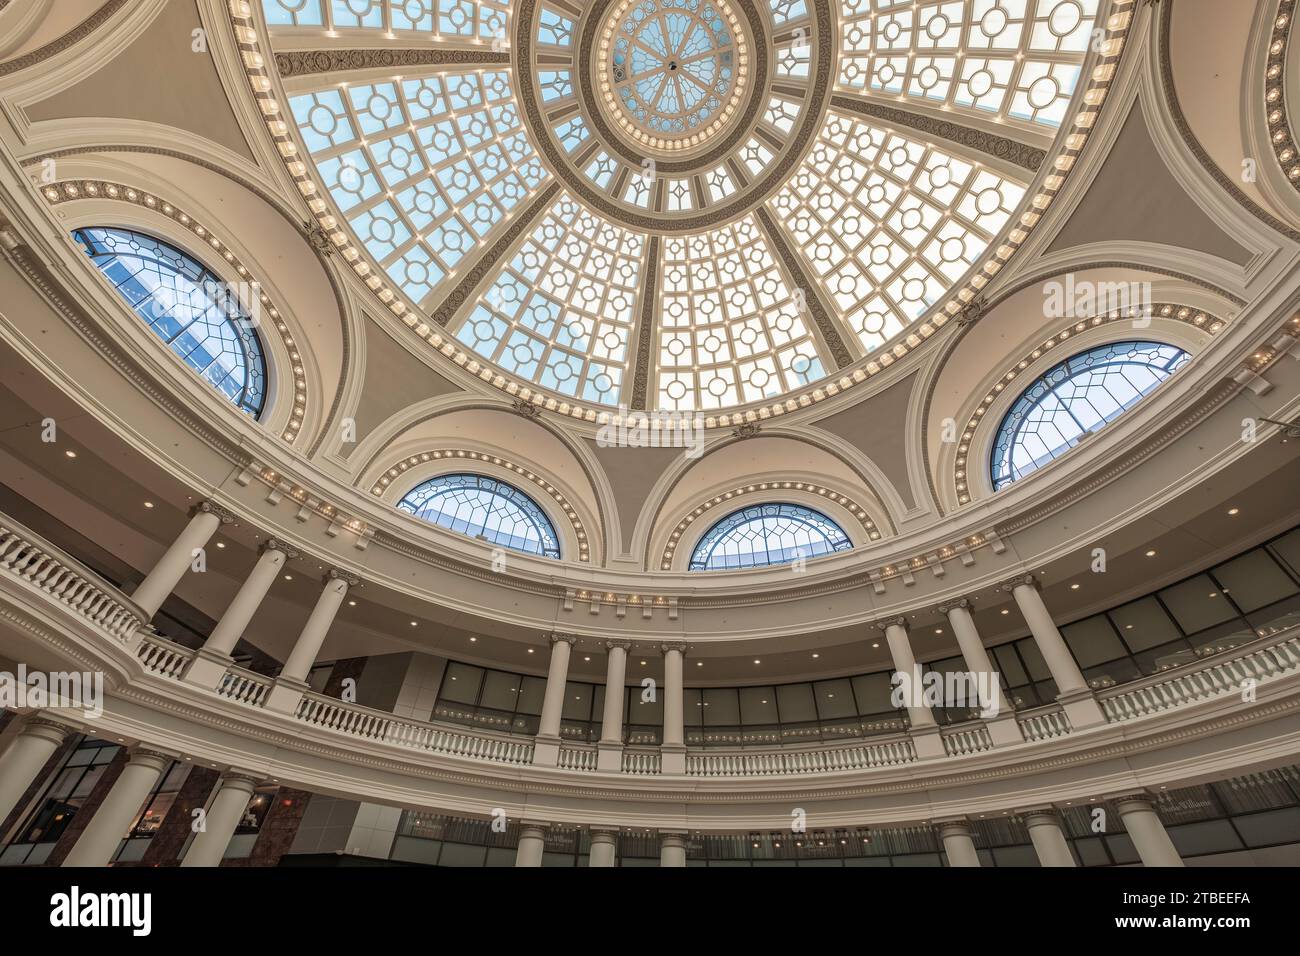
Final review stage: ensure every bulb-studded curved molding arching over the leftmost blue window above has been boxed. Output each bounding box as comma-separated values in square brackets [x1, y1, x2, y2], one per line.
[40, 179, 307, 445]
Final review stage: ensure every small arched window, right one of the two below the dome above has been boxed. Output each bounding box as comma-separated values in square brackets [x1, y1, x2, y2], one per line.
[689, 505, 853, 571]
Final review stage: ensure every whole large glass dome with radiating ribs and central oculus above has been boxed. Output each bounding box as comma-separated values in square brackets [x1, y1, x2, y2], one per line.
[263, 0, 1101, 418]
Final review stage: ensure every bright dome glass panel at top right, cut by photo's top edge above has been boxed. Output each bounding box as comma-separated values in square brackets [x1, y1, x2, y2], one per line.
[839, 0, 1100, 127]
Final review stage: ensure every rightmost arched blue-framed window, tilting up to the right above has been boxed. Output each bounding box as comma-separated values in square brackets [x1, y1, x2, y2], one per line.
[989, 342, 1191, 490]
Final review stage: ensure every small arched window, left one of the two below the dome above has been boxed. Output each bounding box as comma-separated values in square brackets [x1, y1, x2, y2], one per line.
[398, 475, 560, 558]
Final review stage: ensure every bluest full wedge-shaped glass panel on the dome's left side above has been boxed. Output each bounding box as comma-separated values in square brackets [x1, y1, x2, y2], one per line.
[290, 70, 547, 303]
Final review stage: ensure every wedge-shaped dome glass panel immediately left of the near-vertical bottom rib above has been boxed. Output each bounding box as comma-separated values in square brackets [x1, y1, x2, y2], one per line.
[456, 194, 646, 405]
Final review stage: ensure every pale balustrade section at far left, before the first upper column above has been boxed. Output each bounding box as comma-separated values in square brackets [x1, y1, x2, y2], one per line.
[0, 518, 144, 644]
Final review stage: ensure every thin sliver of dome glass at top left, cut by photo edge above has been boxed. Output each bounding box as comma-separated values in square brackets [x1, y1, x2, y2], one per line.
[261, 0, 508, 40]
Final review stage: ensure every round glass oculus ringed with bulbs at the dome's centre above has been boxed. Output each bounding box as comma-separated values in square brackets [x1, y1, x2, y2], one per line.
[598, 0, 750, 155]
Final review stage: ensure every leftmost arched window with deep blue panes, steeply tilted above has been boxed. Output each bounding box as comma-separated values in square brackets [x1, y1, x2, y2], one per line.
[73, 228, 267, 418]
